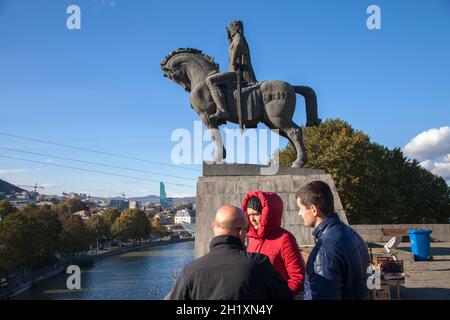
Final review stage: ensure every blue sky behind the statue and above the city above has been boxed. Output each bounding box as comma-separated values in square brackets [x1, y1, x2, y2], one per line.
[0, 0, 450, 196]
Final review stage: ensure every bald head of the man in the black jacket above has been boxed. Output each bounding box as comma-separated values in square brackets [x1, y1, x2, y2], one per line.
[213, 205, 248, 237]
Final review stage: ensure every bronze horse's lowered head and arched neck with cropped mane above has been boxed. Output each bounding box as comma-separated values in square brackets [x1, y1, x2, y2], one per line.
[161, 48, 219, 92]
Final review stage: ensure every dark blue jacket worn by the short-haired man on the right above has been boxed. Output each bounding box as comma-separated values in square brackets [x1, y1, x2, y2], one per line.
[304, 213, 369, 300]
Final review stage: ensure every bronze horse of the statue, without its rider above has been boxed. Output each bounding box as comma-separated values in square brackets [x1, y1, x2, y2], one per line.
[161, 48, 320, 167]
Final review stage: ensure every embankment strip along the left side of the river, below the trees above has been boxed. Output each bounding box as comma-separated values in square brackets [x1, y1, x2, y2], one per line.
[0, 239, 193, 299]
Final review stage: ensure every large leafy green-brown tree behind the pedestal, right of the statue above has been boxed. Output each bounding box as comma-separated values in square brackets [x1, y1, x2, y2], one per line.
[279, 119, 450, 224]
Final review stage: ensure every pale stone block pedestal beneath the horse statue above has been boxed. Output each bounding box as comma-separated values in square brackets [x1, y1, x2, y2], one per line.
[195, 164, 348, 257]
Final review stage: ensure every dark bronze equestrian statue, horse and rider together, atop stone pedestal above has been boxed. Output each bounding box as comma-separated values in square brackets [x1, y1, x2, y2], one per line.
[161, 20, 321, 167]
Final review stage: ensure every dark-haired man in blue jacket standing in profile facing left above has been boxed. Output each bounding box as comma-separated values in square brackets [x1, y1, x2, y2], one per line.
[296, 181, 369, 300]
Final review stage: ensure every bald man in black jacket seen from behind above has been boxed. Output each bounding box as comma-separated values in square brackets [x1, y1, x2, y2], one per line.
[170, 206, 292, 300]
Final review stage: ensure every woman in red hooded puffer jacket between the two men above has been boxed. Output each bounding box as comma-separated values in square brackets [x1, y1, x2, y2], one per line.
[242, 190, 305, 295]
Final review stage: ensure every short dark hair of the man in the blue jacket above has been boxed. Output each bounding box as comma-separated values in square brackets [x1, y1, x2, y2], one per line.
[295, 181, 334, 216]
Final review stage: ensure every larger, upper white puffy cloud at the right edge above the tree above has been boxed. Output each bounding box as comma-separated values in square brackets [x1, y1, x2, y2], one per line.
[403, 127, 450, 160]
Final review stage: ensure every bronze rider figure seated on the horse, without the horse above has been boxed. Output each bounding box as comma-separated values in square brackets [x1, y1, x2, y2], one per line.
[206, 20, 257, 120]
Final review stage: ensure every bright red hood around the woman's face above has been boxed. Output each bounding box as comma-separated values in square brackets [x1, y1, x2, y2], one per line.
[242, 190, 283, 239]
